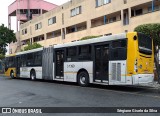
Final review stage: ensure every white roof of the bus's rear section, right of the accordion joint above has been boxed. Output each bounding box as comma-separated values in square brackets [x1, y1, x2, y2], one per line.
[54, 33, 127, 48]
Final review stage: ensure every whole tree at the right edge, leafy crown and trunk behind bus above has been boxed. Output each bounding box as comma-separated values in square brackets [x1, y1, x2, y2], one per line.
[134, 23, 160, 83]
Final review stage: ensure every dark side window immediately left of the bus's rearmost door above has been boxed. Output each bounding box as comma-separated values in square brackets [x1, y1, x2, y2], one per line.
[78, 45, 91, 60]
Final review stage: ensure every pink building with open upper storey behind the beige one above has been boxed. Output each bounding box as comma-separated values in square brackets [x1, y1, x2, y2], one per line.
[8, 0, 58, 31]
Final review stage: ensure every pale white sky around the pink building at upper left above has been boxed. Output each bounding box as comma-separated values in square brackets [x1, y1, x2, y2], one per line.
[0, 0, 69, 30]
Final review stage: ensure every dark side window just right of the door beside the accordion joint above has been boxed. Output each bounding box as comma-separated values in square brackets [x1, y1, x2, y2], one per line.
[67, 47, 77, 62]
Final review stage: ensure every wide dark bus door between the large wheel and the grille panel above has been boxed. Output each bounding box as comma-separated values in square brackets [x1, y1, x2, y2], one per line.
[94, 44, 109, 82]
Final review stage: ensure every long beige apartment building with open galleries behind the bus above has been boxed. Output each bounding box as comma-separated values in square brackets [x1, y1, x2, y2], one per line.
[10, 0, 160, 54]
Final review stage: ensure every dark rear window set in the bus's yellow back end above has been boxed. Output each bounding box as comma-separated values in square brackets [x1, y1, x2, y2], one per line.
[138, 33, 152, 55]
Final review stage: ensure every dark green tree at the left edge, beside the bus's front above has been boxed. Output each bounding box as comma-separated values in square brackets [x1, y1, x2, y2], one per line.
[0, 24, 16, 55]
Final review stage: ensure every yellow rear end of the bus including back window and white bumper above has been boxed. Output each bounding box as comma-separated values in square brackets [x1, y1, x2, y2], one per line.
[127, 33, 154, 85]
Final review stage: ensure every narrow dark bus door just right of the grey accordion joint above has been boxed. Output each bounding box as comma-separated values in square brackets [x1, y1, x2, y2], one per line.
[56, 50, 64, 79]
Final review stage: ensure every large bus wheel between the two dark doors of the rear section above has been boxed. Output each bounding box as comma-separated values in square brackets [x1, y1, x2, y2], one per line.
[78, 71, 89, 87]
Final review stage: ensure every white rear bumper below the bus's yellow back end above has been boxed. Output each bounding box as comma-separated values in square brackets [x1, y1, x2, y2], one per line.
[132, 74, 154, 85]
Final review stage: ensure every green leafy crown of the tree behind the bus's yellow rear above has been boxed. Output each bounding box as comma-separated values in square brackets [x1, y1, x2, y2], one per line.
[134, 23, 160, 46]
